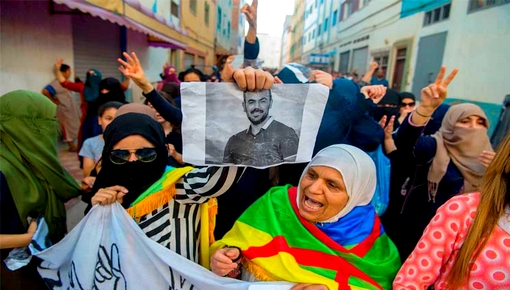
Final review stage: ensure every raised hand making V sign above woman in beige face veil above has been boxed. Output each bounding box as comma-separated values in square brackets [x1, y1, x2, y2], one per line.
[420, 65, 459, 111]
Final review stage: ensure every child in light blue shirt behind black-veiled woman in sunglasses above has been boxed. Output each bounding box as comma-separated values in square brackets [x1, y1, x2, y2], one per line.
[79, 101, 123, 181]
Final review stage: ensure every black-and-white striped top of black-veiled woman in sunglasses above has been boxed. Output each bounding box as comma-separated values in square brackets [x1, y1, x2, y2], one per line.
[138, 166, 244, 263]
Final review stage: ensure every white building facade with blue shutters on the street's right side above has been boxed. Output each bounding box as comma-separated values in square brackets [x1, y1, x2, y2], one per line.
[292, 0, 510, 113]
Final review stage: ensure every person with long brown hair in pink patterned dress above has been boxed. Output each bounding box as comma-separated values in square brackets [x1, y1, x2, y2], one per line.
[393, 132, 510, 290]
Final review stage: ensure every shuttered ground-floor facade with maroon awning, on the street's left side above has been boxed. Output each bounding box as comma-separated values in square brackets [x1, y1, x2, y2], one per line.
[0, 0, 186, 101]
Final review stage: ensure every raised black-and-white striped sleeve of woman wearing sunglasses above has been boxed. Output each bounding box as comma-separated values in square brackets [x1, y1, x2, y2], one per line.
[175, 166, 245, 204]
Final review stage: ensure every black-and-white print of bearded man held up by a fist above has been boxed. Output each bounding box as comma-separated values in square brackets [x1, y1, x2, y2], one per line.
[181, 83, 328, 168]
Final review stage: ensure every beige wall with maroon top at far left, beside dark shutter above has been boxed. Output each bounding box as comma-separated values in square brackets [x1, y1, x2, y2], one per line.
[0, 1, 74, 95]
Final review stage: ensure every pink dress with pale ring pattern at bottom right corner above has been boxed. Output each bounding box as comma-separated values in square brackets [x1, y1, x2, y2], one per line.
[393, 193, 510, 290]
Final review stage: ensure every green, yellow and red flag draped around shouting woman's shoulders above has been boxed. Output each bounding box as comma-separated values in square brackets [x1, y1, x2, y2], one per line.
[211, 186, 400, 289]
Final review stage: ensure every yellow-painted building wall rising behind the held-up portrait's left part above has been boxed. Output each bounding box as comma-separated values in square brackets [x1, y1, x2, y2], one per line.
[178, 0, 216, 74]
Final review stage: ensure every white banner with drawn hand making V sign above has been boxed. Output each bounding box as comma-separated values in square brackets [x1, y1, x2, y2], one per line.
[34, 203, 292, 290]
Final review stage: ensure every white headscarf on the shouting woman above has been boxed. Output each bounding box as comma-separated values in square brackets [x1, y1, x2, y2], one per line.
[297, 144, 377, 223]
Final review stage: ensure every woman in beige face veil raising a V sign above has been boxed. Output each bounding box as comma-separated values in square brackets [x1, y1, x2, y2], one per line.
[392, 66, 494, 259]
